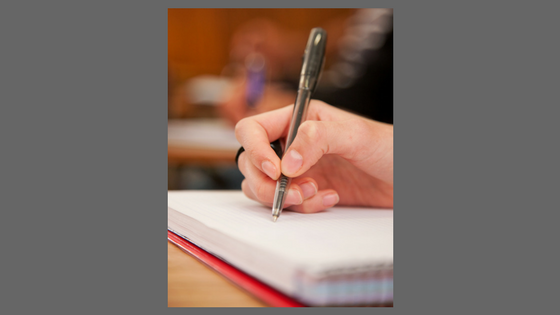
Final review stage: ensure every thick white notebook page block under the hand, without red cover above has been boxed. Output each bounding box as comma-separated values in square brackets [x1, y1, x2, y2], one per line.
[168, 191, 393, 306]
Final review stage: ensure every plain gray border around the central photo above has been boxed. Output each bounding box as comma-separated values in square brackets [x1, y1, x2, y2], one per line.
[0, 1, 558, 314]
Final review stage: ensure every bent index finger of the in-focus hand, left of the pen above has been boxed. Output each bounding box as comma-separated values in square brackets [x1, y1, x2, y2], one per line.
[235, 105, 294, 180]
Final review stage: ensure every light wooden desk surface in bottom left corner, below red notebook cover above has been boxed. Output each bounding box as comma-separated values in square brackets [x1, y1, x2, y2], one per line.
[167, 242, 267, 307]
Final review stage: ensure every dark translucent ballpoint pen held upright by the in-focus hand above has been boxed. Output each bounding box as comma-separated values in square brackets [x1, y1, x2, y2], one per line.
[272, 27, 327, 222]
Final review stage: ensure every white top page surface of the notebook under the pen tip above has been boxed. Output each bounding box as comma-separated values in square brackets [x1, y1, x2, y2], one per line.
[168, 191, 393, 276]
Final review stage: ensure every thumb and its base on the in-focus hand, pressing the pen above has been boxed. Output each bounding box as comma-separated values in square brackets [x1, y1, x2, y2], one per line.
[281, 118, 373, 177]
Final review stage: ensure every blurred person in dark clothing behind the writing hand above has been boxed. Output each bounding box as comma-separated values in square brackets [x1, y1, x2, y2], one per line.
[219, 9, 393, 124]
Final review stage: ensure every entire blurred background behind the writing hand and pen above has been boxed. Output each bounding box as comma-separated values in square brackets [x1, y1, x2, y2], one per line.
[168, 9, 393, 190]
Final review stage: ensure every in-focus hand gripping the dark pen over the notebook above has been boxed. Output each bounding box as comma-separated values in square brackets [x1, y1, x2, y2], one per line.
[235, 100, 393, 213]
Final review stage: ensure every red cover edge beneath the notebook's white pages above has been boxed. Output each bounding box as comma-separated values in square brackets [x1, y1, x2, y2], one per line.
[167, 230, 305, 307]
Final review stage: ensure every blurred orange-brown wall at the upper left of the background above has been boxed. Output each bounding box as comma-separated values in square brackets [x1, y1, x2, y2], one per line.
[168, 9, 355, 118]
